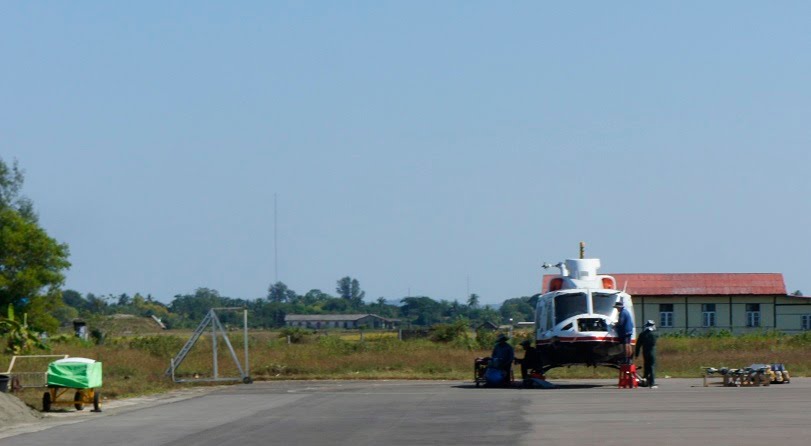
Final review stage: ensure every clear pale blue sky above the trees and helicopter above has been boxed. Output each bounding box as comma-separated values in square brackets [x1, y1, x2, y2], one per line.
[0, 1, 811, 304]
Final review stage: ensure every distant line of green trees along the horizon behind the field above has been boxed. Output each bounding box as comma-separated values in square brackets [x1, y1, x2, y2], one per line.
[55, 276, 536, 328]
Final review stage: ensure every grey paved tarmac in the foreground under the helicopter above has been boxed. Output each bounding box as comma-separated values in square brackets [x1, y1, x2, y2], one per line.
[0, 378, 811, 446]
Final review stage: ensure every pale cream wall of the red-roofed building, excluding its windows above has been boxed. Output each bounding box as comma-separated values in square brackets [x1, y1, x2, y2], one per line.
[633, 296, 811, 334]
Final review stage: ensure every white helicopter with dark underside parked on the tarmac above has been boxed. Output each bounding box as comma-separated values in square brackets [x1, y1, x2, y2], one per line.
[535, 259, 636, 371]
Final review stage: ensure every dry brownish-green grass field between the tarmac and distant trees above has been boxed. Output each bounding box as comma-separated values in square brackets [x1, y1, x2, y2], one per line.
[0, 331, 811, 408]
